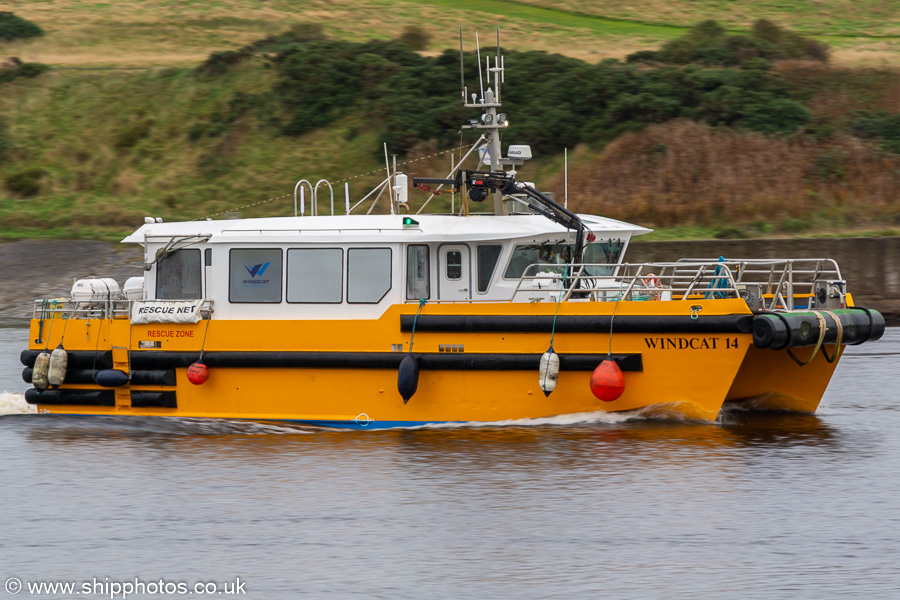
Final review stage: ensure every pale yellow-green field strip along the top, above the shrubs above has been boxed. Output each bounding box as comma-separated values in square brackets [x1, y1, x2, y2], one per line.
[3, 0, 900, 67]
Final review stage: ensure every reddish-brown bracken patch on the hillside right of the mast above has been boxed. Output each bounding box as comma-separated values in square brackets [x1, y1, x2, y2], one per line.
[547, 120, 900, 239]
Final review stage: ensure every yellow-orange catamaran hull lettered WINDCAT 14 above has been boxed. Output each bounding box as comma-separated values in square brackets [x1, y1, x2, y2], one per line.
[22, 299, 835, 428]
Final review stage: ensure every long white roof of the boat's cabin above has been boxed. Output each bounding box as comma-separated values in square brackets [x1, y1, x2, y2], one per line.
[122, 214, 652, 244]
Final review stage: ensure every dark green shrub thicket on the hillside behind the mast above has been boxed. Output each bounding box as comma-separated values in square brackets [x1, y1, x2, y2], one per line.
[262, 35, 811, 153]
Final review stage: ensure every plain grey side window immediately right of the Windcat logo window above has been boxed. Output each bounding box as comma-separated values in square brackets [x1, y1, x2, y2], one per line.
[287, 248, 344, 303]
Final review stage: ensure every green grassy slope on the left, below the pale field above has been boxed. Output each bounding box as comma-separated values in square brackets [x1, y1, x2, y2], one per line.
[0, 65, 408, 238]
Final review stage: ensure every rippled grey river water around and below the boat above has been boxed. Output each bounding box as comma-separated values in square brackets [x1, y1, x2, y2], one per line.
[0, 329, 900, 600]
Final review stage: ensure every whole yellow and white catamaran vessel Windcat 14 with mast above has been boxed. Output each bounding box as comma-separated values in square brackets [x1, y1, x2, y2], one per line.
[21, 34, 884, 428]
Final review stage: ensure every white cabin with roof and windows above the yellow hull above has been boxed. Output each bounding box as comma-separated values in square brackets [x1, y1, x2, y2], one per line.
[125, 215, 649, 319]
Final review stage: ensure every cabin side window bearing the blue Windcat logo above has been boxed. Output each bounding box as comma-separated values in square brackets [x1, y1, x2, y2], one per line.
[228, 248, 282, 303]
